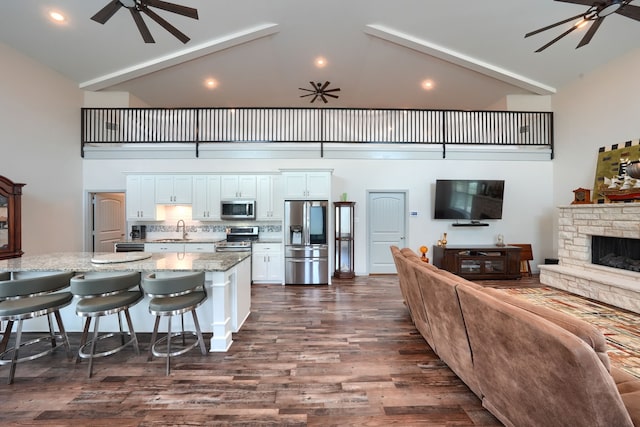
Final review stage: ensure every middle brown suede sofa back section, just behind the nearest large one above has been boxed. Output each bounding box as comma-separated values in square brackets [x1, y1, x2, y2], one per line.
[409, 263, 481, 397]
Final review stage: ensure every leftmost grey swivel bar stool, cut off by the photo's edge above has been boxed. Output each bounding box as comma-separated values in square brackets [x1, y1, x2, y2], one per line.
[0, 272, 74, 384]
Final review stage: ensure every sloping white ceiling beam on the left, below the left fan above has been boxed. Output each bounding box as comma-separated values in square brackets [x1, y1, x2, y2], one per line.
[79, 24, 280, 91]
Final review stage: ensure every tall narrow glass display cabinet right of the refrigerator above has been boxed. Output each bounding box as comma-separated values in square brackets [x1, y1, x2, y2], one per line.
[333, 202, 356, 279]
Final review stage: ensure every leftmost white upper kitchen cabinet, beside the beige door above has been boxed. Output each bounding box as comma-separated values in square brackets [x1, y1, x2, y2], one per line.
[126, 175, 164, 221]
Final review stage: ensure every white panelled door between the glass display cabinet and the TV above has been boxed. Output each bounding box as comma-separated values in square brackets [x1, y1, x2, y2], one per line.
[367, 192, 407, 274]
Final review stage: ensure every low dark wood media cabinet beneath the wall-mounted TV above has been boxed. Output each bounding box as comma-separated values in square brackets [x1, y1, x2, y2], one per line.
[433, 245, 520, 280]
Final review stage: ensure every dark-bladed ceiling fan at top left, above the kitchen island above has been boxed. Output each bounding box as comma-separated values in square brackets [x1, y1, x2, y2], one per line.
[91, 0, 198, 43]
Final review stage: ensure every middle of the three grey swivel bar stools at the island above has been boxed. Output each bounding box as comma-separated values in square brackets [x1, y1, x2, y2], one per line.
[71, 272, 143, 378]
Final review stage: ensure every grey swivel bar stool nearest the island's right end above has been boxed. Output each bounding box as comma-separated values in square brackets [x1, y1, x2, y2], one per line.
[142, 271, 207, 375]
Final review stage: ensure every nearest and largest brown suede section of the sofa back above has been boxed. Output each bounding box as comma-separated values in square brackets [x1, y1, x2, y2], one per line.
[457, 285, 633, 427]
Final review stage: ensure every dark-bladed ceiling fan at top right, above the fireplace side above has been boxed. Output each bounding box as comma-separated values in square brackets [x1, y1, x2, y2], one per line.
[525, 0, 640, 52]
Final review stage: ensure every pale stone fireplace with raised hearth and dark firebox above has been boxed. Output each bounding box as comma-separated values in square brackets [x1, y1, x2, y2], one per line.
[539, 203, 640, 313]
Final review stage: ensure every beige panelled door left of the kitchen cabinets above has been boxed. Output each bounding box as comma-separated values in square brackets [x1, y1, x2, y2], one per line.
[93, 193, 126, 252]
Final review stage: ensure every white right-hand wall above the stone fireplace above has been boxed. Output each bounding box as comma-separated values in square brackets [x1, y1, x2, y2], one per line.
[553, 49, 640, 254]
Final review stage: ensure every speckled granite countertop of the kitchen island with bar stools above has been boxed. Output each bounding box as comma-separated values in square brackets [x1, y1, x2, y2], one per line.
[0, 251, 251, 272]
